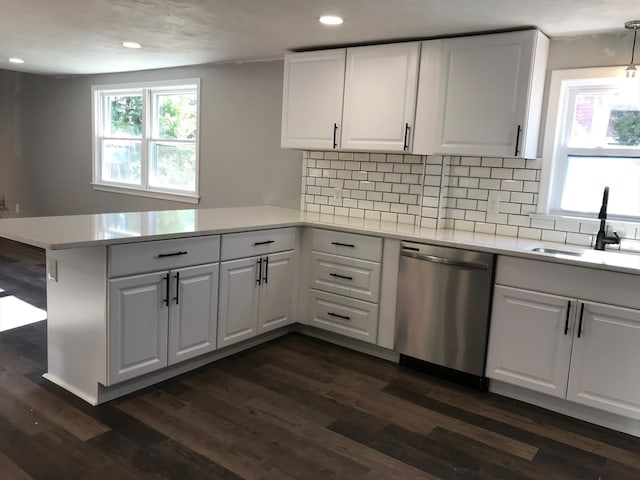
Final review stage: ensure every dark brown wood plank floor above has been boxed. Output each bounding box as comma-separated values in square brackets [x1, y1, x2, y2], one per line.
[0, 238, 640, 480]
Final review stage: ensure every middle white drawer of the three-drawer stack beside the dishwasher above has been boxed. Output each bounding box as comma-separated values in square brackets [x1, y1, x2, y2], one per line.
[309, 252, 380, 303]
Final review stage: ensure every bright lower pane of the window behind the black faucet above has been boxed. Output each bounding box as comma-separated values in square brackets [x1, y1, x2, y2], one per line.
[560, 155, 640, 217]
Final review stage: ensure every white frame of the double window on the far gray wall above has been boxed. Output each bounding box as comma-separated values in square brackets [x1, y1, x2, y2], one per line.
[91, 78, 201, 204]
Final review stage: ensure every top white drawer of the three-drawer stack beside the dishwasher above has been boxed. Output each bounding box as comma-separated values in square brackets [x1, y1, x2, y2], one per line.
[313, 228, 382, 262]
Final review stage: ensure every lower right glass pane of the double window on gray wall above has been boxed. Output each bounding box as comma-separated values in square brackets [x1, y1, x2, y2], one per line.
[149, 143, 196, 192]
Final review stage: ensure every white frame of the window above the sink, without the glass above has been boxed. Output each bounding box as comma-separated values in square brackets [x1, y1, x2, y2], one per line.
[536, 66, 640, 219]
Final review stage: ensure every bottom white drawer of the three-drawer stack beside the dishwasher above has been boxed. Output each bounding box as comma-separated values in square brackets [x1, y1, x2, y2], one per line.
[309, 290, 378, 343]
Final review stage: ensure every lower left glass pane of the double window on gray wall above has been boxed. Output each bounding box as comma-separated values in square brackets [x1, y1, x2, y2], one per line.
[102, 140, 142, 185]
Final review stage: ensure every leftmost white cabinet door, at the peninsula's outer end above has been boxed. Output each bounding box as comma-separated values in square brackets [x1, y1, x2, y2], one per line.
[108, 272, 169, 385]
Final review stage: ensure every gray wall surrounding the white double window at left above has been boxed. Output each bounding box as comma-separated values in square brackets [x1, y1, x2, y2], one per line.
[22, 61, 301, 215]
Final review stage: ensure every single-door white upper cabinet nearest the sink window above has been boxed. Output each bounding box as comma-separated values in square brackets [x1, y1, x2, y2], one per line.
[414, 30, 549, 158]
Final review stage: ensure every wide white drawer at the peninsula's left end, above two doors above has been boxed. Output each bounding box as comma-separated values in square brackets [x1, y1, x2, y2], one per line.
[109, 235, 220, 277]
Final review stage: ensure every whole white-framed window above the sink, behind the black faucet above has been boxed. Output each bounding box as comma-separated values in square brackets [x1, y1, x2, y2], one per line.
[542, 68, 640, 221]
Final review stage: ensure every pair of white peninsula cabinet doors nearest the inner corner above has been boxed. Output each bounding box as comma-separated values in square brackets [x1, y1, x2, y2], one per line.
[218, 251, 297, 347]
